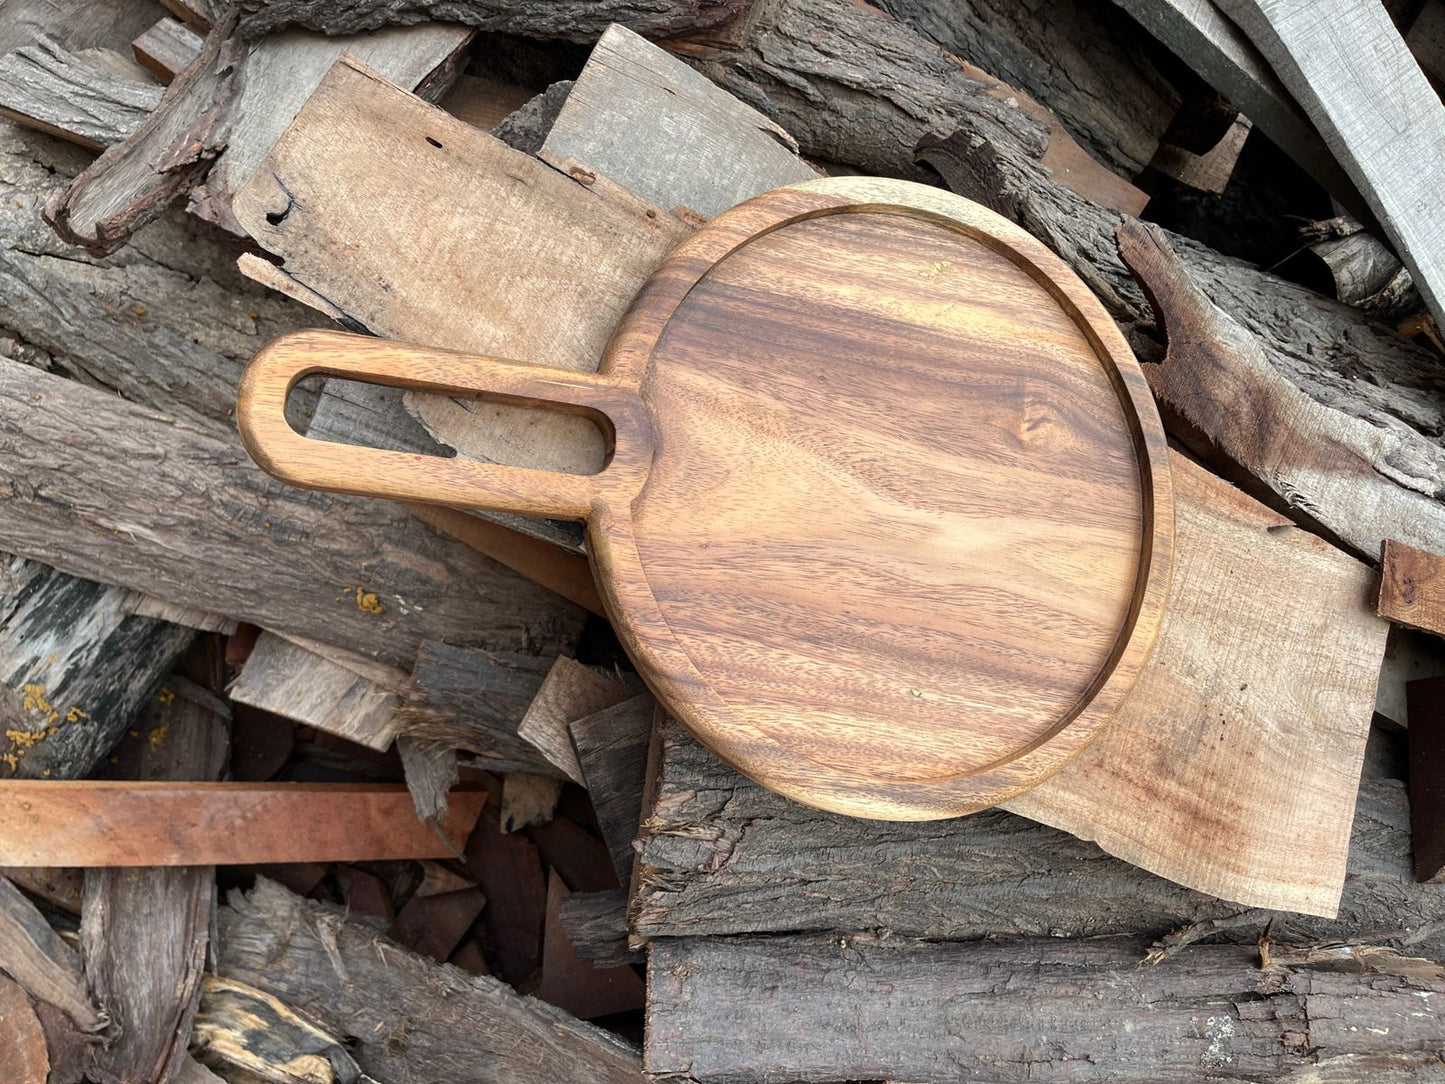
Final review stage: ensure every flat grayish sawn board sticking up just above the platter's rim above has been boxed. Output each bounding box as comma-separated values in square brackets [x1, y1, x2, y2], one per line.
[540, 26, 818, 217]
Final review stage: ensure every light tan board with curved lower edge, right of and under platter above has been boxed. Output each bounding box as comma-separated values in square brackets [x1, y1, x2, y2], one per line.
[1006, 455, 1389, 916]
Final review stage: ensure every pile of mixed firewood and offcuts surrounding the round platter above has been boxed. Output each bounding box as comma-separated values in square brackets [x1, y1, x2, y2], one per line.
[0, 0, 1445, 1084]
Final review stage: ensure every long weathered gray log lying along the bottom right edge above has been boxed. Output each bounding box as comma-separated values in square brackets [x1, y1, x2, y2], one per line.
[646, 935, 1445, 1084]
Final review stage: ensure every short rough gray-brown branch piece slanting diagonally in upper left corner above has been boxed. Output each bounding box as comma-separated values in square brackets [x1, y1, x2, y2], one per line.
[45, 7, 246, 253]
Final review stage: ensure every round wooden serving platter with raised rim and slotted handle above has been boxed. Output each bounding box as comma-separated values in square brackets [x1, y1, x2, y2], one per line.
[237, 178, 1173, 820]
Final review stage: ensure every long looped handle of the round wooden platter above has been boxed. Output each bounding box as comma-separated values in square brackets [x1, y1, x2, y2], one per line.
[236, 331, 652, 520]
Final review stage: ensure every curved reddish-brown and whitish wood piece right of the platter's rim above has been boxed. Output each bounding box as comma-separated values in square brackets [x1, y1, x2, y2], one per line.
[1118, 221, 1445, 558]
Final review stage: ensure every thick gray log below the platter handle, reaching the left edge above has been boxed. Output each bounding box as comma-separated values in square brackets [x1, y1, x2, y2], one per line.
[0, 360, 581, 668]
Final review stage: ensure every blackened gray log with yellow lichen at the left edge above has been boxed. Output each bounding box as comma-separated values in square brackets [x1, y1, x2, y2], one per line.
[0, 555, 195, 779]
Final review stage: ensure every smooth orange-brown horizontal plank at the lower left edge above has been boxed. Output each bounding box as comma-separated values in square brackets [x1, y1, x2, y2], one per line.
[0, 780, 486, 867]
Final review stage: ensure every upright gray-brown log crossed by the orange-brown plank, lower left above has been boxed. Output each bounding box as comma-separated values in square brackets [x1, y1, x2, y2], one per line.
[81, 645, 228, 1084]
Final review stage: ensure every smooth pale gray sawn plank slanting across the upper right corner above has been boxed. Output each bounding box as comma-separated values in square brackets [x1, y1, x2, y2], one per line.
[1218, 0, 1445, 324]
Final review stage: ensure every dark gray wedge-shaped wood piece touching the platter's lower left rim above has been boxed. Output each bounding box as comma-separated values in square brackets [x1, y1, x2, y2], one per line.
[568, 692, 657, 885]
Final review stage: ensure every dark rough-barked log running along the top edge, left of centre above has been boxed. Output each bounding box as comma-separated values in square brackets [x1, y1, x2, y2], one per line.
[240, 0, 753, 42]
